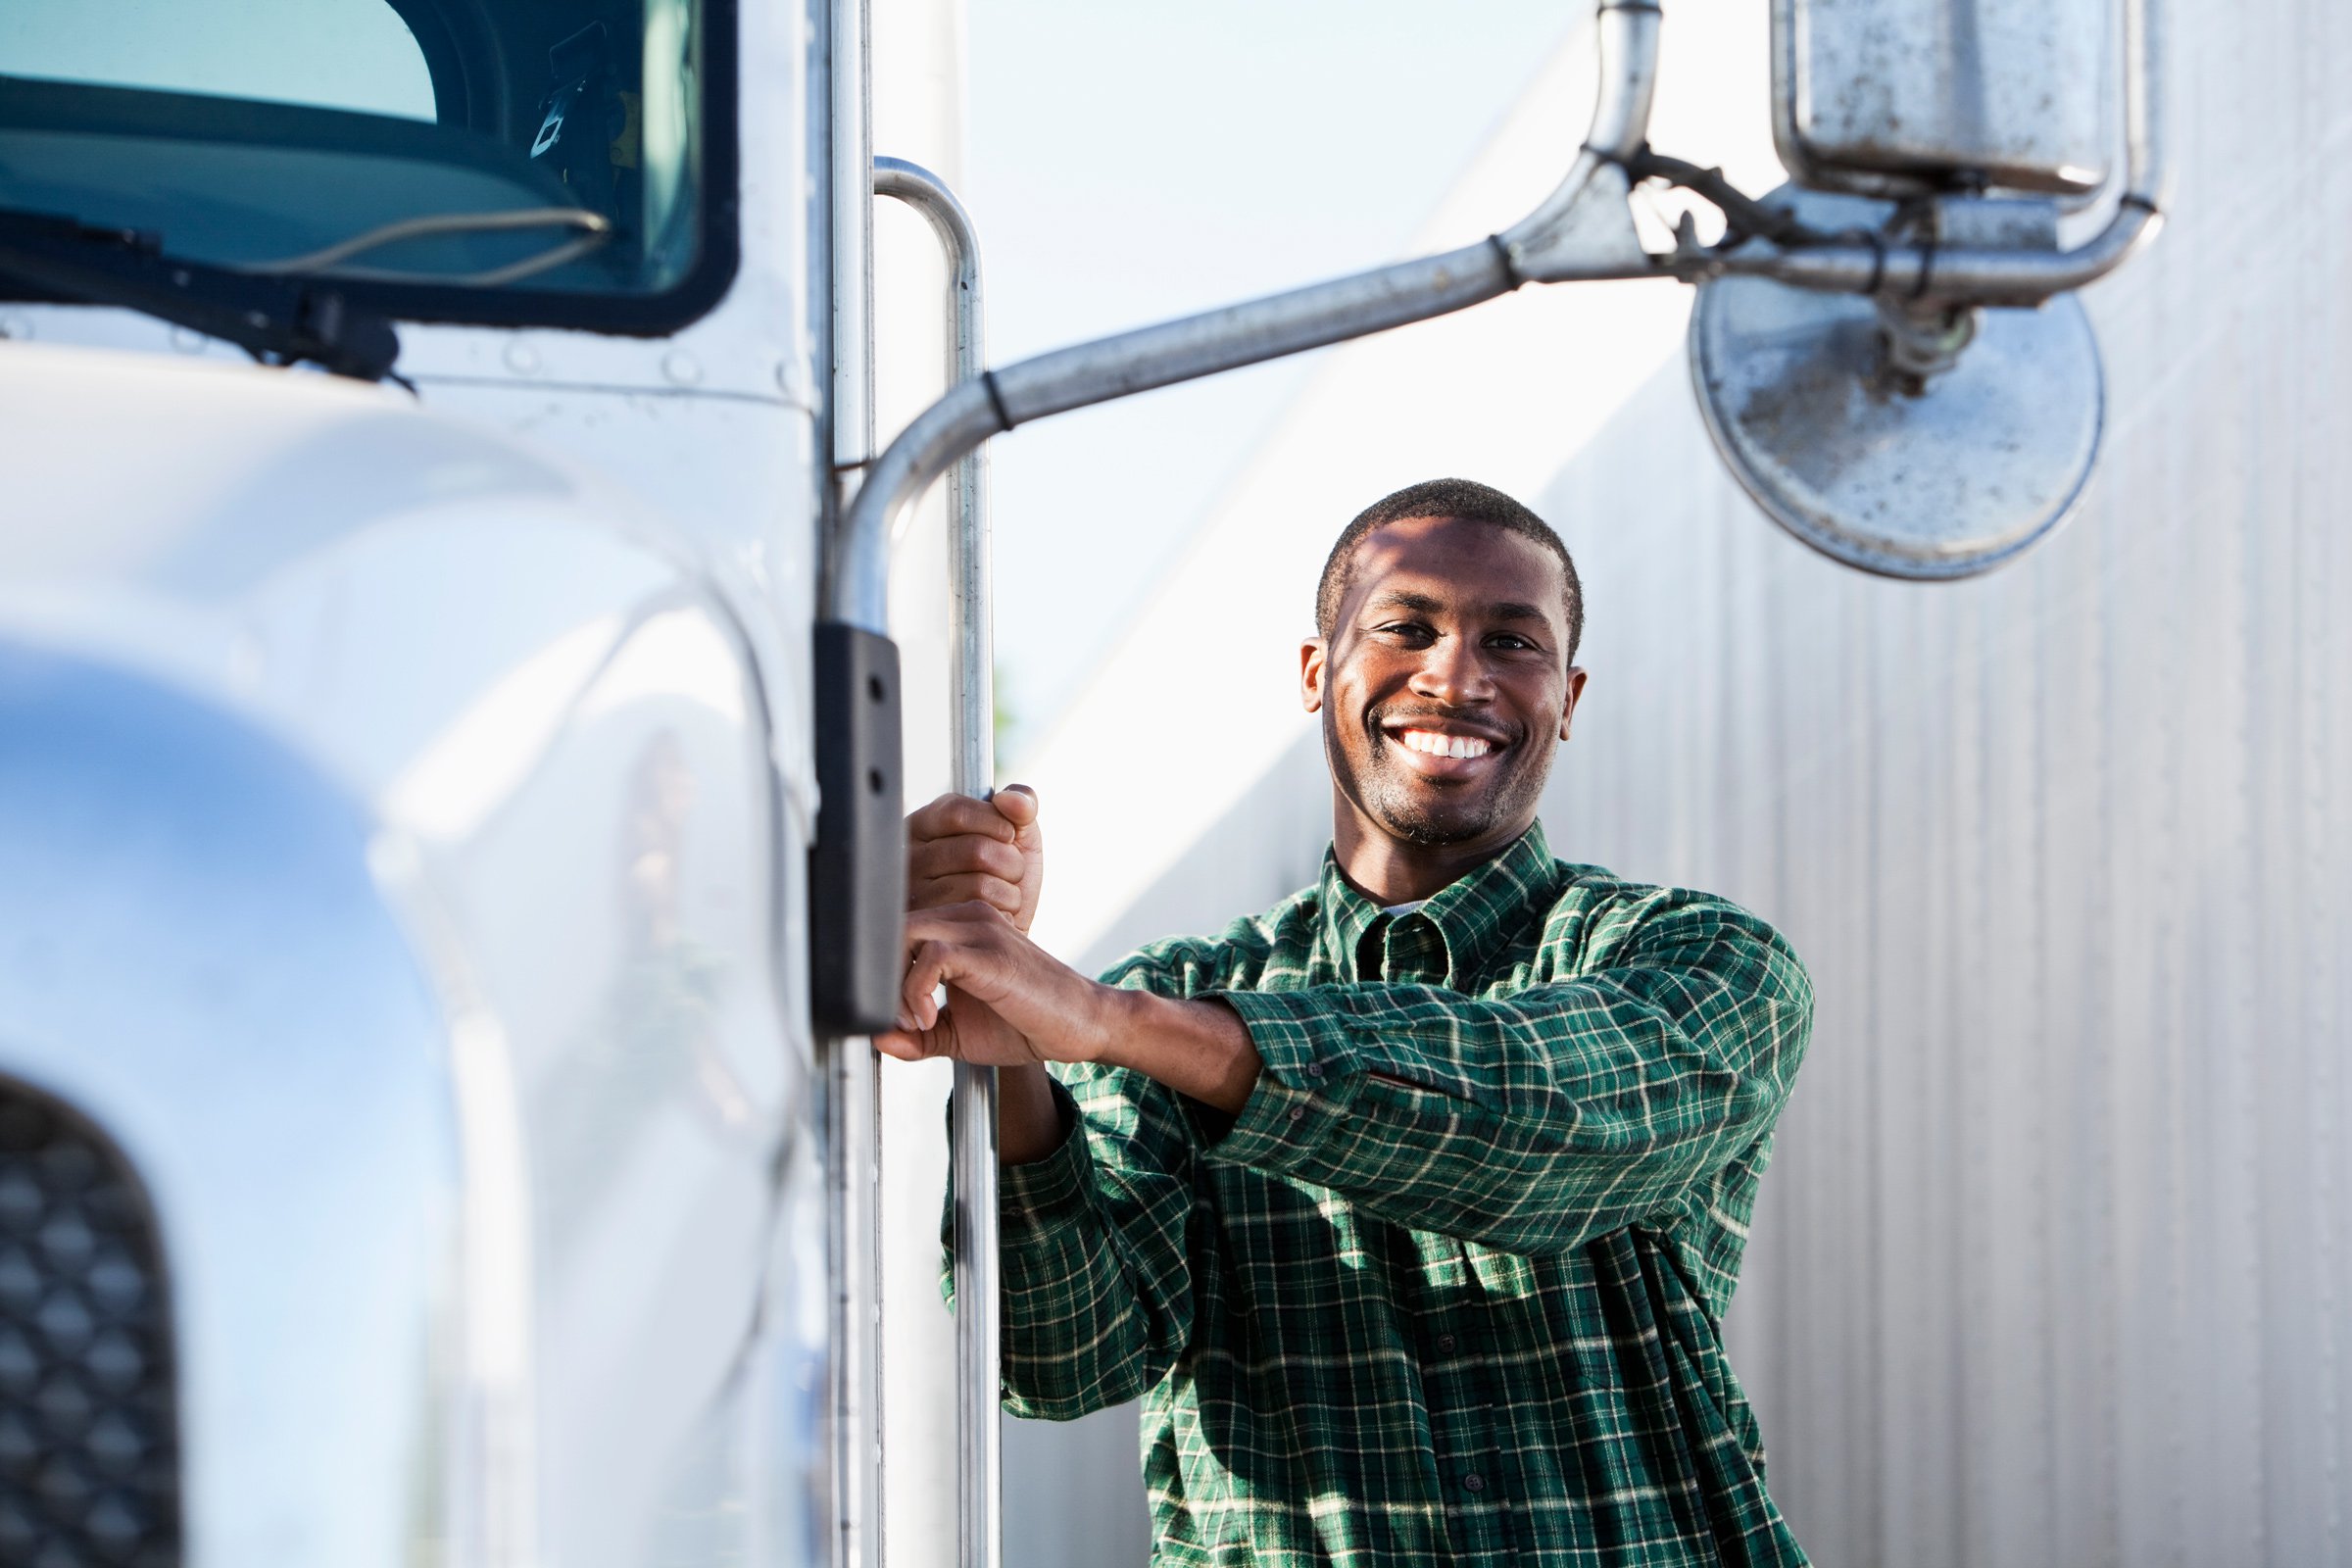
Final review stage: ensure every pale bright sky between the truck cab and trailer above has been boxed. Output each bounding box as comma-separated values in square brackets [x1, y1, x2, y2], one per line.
[964, 0, 1583, 766]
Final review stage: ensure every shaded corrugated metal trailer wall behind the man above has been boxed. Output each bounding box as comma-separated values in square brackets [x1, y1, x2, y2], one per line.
[1015, 0, 2352, 1568]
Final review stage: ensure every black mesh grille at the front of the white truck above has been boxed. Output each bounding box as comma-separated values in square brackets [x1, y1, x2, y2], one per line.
[0, 1081, 178, 1568]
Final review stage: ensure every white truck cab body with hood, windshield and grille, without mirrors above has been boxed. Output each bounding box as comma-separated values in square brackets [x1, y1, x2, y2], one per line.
[0, 0, 833, 1568]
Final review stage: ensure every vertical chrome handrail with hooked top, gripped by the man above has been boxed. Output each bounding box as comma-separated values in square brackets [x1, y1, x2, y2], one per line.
[875, 158, 1004, 1568]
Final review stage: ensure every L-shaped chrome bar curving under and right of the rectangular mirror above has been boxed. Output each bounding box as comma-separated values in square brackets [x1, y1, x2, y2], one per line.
[1707, 0, 2171, 306]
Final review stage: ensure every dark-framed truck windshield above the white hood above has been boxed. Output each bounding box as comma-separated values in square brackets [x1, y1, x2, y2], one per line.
[0, 0, 734, 329]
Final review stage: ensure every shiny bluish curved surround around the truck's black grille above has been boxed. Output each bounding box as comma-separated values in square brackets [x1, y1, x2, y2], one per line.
[0, 644, 468, 1568]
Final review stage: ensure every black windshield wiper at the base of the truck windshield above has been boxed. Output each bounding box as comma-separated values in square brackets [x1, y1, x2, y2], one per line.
[0, 207, 400, 381]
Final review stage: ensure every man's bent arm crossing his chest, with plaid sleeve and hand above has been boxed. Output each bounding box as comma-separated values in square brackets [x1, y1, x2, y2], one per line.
[877, 891, 1811, 1253]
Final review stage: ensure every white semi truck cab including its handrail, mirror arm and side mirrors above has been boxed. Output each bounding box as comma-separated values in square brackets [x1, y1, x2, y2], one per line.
[0, 0, 2162, 1568]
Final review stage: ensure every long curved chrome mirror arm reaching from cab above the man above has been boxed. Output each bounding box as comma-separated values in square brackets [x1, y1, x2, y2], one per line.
[825, 0, 1658, 635]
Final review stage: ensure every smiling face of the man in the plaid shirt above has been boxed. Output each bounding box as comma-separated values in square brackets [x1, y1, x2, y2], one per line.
[1300, 517, 1586, 851]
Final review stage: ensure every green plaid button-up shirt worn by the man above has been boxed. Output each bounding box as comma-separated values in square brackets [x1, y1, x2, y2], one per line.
[964, 827, 1813, 1568]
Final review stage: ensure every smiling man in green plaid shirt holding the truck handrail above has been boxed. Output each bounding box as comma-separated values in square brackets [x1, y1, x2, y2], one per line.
[877, 479, 1813, 1568]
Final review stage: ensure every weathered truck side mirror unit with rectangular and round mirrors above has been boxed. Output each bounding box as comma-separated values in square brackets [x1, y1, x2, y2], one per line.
[1691, 0, 2162, 578]
